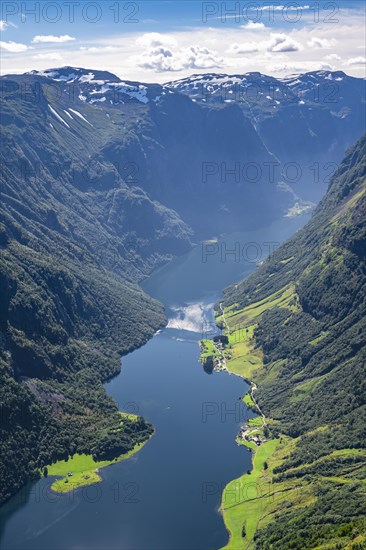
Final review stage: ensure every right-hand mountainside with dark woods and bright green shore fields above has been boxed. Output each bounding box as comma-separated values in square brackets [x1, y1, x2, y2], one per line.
[213, 136, 366, 550]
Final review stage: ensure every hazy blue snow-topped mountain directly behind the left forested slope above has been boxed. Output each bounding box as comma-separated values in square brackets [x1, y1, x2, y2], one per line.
[7, 67, 293, 237]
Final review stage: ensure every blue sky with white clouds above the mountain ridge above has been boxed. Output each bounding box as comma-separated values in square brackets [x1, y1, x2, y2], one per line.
[0, 0, 365, 82]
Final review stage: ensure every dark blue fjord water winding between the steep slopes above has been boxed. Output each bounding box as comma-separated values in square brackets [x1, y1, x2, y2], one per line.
[0, 217, 306, 550]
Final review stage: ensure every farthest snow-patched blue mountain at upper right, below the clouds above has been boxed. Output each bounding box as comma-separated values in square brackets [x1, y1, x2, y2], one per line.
[166, 71, 365, 202]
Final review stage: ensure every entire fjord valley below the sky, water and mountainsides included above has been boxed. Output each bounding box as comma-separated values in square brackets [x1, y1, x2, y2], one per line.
[0, 66, 365, 550]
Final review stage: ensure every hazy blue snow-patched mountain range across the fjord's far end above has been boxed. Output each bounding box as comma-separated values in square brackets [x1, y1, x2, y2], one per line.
[2, 67, 365, 229]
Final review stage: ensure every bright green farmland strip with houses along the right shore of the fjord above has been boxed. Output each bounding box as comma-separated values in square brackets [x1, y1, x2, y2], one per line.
[212, 285, 308, 550]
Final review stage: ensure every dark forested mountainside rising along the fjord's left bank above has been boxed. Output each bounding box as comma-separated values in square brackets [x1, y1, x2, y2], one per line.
[0, 72, 191, 502]
